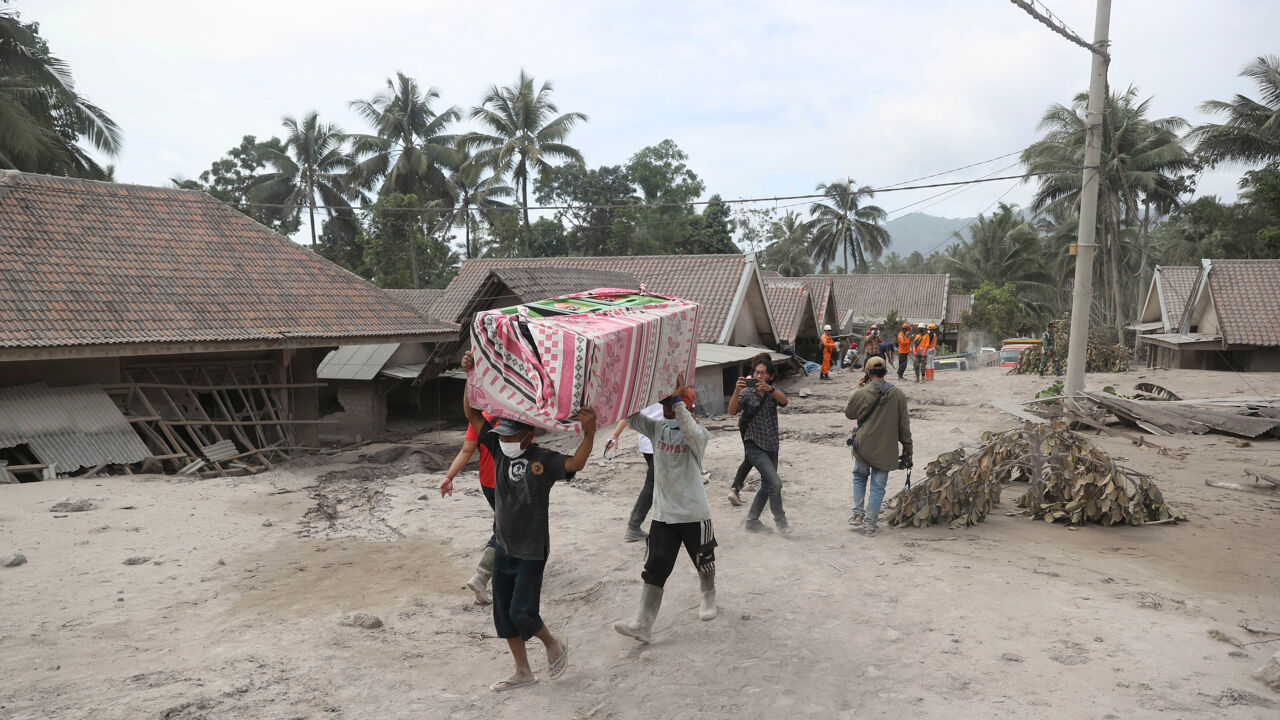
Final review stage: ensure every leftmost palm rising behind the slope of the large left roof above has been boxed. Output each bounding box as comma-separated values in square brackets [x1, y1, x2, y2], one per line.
[248, 110, 353, 249]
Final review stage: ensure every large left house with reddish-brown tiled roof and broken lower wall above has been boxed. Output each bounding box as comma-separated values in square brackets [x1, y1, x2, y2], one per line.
[0, 170, 457, 480]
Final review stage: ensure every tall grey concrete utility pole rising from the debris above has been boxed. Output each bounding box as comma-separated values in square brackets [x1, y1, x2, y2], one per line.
[1062, 0, 1111, 395]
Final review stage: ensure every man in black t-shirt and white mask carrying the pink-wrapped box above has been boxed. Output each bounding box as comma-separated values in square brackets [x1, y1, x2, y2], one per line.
[462, 352, 595, 692]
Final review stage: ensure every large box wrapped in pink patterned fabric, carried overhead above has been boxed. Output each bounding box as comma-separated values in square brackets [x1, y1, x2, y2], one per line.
[467, 288, 698, 433]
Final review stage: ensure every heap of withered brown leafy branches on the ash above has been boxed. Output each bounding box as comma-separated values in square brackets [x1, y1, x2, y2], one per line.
[886, 421, 1185, 528]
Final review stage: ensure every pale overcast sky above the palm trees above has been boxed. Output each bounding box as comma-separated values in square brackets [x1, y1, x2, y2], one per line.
[30, 0, 1280, 237]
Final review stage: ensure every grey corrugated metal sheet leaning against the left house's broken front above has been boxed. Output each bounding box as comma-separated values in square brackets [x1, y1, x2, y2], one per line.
[0, 383, 151, 473]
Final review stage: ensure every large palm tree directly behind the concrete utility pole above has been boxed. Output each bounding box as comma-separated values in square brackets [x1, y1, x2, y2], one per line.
[1021, 86, 1194, 342]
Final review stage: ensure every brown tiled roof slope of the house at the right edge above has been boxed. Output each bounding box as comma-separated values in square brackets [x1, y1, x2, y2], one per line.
[1208, 260, 1280, 346]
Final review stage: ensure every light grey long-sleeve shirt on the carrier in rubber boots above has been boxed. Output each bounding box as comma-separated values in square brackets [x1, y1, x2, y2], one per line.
[627, 402, 712, 524]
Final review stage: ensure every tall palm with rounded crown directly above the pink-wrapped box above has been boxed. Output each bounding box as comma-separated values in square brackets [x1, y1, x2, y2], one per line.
[467, 70, 588, 254]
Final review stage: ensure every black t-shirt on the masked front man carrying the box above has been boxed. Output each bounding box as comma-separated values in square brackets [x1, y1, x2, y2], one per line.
[480, 420, 573, 560]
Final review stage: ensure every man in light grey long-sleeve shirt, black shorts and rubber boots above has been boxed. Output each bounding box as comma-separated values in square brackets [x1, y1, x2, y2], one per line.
[613, 375, 717, 643]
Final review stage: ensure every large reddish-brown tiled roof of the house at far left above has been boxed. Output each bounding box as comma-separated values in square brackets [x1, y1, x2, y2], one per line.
[0, 172, 456, 348]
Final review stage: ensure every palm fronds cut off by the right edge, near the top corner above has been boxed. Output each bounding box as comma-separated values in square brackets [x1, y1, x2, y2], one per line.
[1190, 55, 1280, 165]
